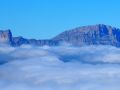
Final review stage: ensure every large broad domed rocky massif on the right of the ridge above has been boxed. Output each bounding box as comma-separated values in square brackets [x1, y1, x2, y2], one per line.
[53, 24, 120, 47]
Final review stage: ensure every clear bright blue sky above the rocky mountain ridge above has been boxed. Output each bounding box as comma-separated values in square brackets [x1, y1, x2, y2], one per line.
[0, 0, 120, 39]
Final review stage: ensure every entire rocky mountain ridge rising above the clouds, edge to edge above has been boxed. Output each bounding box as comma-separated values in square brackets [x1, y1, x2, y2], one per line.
[0, 24, 120, 47]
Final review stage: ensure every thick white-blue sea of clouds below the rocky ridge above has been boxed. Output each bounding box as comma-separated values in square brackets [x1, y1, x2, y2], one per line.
[0, 45, 120, 90]
